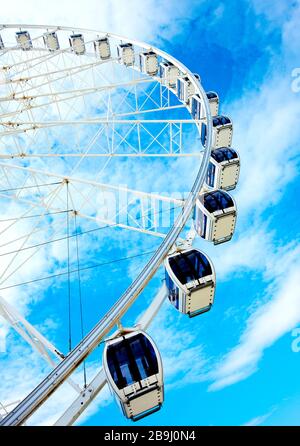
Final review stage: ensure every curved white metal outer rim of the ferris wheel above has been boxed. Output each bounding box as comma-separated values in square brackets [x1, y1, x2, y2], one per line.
[0, 24, 212, 425]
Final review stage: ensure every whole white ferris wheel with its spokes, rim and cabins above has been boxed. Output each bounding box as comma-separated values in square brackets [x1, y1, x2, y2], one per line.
[0, 25, 240, 425]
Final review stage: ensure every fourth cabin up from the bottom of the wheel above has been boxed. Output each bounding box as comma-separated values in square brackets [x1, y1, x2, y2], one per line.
[206, 147, 240, 190]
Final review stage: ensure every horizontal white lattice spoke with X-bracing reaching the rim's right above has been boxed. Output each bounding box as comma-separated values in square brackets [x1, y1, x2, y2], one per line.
[0, 120, 204, 161]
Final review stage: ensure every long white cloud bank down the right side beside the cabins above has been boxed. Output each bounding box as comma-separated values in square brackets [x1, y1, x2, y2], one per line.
[202, 0, 300, 390]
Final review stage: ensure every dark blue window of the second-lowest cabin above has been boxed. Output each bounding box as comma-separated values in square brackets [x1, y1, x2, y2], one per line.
[169, 249, 212, 285]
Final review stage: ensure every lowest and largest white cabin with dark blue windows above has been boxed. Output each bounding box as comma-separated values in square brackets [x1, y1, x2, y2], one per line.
[103, 330, 164, 421]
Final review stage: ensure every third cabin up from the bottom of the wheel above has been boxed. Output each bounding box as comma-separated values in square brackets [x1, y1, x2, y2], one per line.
[194, 190, 236, 245]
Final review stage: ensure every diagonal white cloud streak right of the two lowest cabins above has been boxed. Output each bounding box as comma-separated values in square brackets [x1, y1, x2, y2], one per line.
[209, 247, 300, 390]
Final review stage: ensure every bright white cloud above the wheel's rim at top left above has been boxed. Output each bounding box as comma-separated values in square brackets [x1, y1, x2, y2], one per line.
[2, 0, 199, 41]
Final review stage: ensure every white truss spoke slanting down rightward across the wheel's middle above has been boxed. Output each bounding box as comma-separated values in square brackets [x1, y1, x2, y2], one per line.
[0, 163, 184, 237]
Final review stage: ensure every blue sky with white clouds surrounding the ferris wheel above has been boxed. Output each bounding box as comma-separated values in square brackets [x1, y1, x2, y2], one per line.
[0, 0, 300, 425]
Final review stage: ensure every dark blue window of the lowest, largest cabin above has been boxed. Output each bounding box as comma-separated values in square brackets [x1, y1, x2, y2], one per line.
[107, 334, 158, 389]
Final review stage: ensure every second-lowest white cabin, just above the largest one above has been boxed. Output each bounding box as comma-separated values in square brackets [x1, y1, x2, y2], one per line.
[165, 248, 216, 317]
